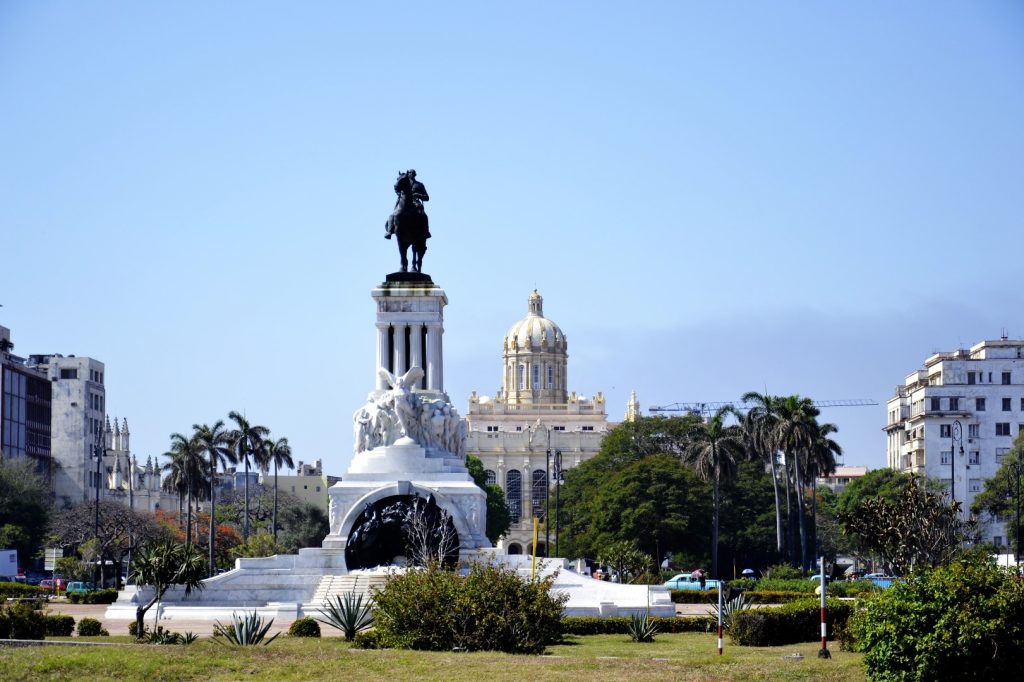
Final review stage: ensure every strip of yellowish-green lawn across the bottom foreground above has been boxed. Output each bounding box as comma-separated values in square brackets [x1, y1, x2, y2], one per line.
[0, 633, 866, 682]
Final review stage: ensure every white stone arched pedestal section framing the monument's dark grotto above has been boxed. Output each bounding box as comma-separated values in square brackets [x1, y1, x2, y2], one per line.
[323, 438, 490, 558]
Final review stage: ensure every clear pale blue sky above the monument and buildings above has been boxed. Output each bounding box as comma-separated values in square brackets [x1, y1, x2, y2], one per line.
[0, 0, 1024, 473]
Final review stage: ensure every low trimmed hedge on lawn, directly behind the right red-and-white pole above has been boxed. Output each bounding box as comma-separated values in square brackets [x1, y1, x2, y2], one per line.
[729, 599, 853, 646]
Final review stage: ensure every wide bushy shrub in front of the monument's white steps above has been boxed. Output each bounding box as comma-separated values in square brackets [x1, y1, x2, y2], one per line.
[374, 563, 567, 653]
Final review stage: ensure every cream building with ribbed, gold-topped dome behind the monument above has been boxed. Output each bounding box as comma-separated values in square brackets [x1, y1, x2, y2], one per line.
[466, 290, 608, 556]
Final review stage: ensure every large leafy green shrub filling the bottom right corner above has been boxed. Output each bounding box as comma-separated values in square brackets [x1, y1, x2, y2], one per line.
[851, 557, 1024, 680]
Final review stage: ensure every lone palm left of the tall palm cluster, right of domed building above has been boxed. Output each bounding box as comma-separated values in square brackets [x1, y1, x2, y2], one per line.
[683, 406, 744, 578]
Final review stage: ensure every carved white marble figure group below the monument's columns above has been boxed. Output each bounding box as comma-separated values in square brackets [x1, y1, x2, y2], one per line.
[352, 367, 466, 458]
